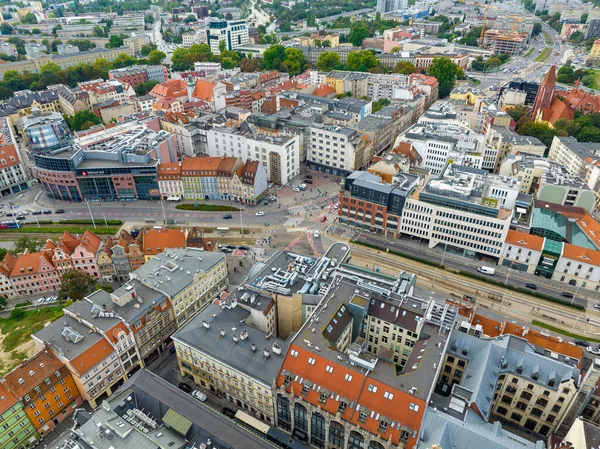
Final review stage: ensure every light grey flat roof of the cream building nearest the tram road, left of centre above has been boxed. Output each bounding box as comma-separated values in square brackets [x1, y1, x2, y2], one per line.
[129, 248, 225, 298]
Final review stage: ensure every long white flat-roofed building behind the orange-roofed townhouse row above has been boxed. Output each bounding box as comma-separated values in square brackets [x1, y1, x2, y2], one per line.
[207, 123, 300, 185]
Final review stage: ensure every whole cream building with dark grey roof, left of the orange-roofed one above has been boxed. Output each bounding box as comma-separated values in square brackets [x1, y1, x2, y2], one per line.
[173, 302, 288, 425]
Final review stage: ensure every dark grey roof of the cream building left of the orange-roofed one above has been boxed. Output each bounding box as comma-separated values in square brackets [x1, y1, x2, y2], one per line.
[173, 304, 289, 387]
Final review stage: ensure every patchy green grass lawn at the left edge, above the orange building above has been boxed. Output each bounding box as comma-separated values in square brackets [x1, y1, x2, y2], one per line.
[0, 306, 63, 373]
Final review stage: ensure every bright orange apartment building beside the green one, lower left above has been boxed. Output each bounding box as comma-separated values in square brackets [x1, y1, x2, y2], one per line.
[4, 348, 83, 440]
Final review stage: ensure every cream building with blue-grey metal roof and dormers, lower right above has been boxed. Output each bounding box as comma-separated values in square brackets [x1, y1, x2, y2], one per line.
[438, 326, 581, 438]
